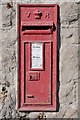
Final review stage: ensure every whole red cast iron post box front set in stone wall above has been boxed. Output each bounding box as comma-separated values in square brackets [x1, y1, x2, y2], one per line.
[18, 4, 58, 111]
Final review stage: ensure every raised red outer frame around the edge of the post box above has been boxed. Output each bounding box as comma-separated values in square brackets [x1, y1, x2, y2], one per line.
[17, 4, 58, 111]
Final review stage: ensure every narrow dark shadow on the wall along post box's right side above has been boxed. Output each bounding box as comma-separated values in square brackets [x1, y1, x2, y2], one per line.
[57, 6, 61, 112]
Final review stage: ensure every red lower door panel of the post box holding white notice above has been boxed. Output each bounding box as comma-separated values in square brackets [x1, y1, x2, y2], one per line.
[25, 42, 51, 105]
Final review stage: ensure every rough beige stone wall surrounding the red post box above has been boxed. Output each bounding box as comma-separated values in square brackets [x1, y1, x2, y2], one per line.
[0, 0, 80, 120]
